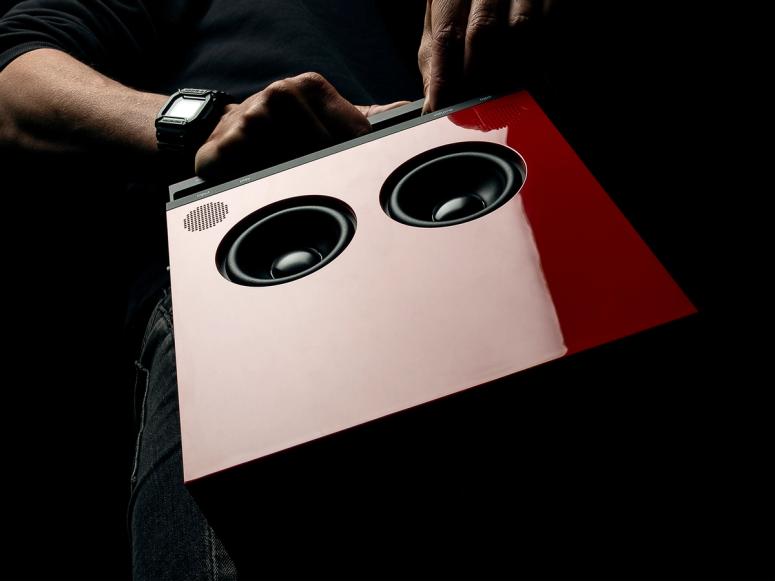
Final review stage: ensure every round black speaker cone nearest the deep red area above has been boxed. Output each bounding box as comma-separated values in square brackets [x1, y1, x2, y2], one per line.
[380, 141, 526, 228]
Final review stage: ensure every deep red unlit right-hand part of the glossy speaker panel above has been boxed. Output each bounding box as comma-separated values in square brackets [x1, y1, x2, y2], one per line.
[450, 92, 695, 353]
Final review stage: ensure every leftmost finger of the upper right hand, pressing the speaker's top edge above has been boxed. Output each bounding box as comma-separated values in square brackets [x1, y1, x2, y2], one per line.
[424, 0, 471, 110]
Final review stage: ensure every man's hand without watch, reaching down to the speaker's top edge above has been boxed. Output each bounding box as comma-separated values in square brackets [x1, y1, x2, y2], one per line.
[418, 0, 551, 112]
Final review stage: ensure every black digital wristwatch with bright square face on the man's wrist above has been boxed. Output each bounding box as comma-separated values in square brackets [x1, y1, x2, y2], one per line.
[156, 89, 235, 151]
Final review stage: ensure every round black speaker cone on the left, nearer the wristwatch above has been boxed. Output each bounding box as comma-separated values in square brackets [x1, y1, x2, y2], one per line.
[216, 196, 356, 286]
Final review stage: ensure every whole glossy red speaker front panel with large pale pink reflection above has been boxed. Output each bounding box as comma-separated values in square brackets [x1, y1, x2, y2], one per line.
[167, 92, 694, 481]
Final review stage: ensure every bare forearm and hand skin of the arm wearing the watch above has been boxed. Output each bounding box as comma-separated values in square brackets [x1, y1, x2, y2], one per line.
[0, 49, 404, 179]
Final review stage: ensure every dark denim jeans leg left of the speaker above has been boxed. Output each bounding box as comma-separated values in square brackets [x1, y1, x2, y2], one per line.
[128, 289, 237, 581]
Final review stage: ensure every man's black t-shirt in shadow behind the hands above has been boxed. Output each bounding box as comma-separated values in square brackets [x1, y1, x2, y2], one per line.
[0, 0, 424, 104]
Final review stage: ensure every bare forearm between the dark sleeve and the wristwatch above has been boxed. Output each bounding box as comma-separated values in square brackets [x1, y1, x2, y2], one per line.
[0, 49, 167, 157]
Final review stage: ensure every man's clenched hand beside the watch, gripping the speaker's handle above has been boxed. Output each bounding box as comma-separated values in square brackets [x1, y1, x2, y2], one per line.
[195, 73, 405, 179]
